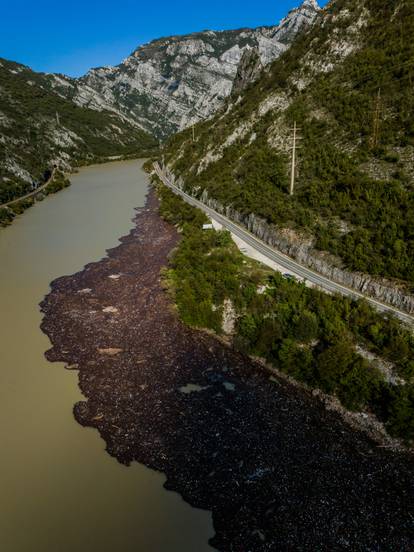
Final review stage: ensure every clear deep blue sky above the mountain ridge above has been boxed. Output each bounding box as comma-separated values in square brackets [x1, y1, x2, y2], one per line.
[0, 0, 326, 76]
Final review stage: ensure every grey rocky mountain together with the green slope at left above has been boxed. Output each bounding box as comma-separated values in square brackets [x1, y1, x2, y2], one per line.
[0, 0, 320, 207]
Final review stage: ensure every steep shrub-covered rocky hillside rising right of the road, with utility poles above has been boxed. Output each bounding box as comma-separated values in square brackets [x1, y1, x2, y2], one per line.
[163, 0, 414, 311]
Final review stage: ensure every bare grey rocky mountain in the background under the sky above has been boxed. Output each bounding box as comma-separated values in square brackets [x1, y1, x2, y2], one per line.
[42, 0, 320, 138]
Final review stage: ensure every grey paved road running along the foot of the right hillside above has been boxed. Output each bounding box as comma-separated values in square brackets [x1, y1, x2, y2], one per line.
[154, 165, 414, 324]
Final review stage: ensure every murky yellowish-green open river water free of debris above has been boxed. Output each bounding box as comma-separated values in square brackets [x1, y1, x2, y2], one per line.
[0, 157, 213, 552]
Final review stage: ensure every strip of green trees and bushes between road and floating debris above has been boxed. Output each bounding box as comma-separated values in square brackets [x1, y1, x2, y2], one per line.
[157, 179, 414, 441]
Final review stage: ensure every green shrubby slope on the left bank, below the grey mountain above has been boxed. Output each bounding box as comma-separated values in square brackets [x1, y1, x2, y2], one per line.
[0, 59, 155, 204]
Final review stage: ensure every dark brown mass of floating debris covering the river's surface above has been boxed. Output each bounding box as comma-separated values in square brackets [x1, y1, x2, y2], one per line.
[42, 187, 414, 552]
